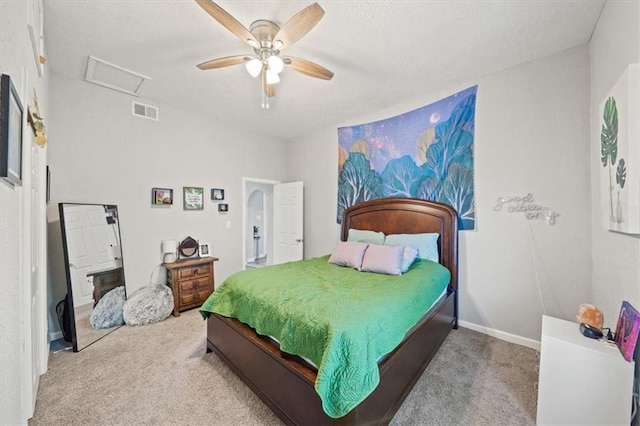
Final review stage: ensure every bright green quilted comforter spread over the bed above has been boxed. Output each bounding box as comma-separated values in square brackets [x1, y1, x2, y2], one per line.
[200, 256, 450, 418]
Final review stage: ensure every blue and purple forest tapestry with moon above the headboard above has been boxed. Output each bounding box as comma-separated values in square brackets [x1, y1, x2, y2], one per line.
[337, 86, 478, 230]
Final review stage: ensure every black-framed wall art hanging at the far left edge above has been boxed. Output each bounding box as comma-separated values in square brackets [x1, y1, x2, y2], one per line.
[0, 74, 23, 186]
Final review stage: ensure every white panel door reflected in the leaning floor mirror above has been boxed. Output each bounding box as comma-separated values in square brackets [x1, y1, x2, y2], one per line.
[64, 204, 116, 309]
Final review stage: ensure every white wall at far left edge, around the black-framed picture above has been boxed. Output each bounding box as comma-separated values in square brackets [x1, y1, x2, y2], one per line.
[0, 1, 48, 425]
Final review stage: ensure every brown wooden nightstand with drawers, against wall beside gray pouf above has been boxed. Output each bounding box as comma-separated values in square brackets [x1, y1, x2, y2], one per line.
[162, 257, 218, 316]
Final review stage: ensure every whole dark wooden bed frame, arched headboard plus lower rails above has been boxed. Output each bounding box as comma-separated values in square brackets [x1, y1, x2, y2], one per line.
[207, 198, 458, 425]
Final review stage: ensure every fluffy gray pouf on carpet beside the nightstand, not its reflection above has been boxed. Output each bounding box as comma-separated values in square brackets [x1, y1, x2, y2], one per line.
[123, 284, 173, 325]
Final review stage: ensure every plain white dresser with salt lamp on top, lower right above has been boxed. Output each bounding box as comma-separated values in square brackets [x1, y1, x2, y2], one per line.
[537, 315, 634, 426]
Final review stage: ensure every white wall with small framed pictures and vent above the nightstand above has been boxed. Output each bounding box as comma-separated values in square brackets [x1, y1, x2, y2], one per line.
[49, 74, 286, 332]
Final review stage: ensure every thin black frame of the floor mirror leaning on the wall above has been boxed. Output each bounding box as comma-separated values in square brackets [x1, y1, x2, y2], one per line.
[58, 203, 127, 352]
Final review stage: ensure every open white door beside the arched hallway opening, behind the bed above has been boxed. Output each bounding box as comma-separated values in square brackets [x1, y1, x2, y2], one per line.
[273, 182, 304, 264]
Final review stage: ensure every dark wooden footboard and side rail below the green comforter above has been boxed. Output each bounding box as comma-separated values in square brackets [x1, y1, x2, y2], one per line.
[207, 292, 456, 425]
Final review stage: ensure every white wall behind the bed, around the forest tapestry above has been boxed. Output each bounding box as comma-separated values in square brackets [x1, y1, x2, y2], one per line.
[288, 46, 591, 340]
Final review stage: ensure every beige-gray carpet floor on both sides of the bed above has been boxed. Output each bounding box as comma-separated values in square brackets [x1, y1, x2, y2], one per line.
[29, 310, 538, 426]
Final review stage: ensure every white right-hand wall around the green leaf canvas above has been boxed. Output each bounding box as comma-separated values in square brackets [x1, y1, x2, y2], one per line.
[589, 1, 640, 334]
